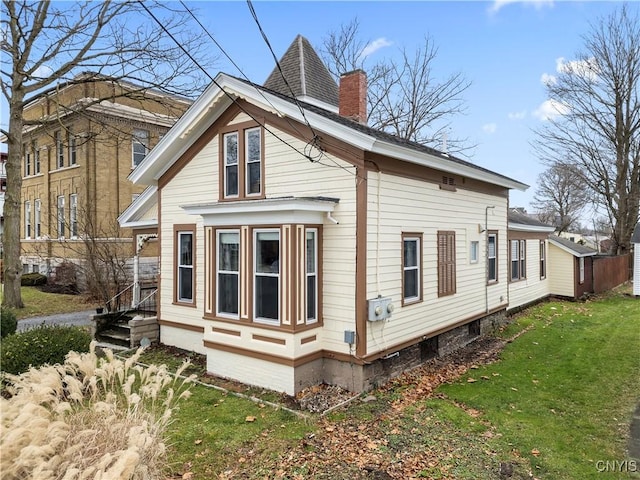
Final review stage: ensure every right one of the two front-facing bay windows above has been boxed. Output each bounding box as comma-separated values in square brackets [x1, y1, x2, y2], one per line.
[253, 229, 280, 325]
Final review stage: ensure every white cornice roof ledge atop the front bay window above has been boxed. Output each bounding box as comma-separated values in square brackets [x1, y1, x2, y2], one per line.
[181, 198, 336, 226]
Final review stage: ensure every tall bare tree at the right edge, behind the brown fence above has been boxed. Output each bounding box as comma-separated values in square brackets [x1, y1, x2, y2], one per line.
[534, 5, 640, 254]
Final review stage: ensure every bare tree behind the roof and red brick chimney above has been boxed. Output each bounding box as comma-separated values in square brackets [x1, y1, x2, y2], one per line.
[321, 19, 472, 153]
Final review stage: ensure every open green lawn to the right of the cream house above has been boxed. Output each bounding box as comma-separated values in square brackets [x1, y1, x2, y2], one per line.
[440, 296, 640, 479]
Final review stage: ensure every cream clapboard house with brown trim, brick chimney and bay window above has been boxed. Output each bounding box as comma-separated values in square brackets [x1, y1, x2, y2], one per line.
[121, 36, 528, 394]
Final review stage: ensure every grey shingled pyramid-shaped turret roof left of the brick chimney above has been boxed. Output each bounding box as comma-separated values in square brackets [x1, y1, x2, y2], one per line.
[264, 35, 338, 112]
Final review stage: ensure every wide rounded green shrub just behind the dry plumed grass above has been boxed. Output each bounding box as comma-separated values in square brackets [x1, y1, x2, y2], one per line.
[0, 325, 91, 375]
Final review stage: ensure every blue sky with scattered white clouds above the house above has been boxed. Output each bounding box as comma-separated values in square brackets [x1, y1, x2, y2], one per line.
[2, 0, 621, 211]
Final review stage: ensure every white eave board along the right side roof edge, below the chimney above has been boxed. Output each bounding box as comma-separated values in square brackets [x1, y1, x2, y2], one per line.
[372, 140, 529, 192]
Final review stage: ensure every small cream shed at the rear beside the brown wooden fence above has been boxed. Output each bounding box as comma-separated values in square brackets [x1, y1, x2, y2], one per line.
[548, 235, 598, 299]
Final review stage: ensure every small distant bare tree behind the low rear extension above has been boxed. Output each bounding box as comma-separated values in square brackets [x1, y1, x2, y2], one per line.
[533, 165, 590, 233]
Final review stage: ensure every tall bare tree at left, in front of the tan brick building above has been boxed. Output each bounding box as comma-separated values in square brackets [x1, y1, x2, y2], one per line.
[0, 0, 212, 308]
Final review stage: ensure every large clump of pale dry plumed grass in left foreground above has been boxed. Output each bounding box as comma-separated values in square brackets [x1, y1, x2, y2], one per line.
[0, 343, 192, 480]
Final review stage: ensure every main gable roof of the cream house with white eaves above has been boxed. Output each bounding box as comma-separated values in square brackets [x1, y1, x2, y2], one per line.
[129, 73, 528, 190]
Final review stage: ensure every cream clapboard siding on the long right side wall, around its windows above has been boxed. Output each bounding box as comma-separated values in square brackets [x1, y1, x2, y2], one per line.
[367, 173, 507, 353]
